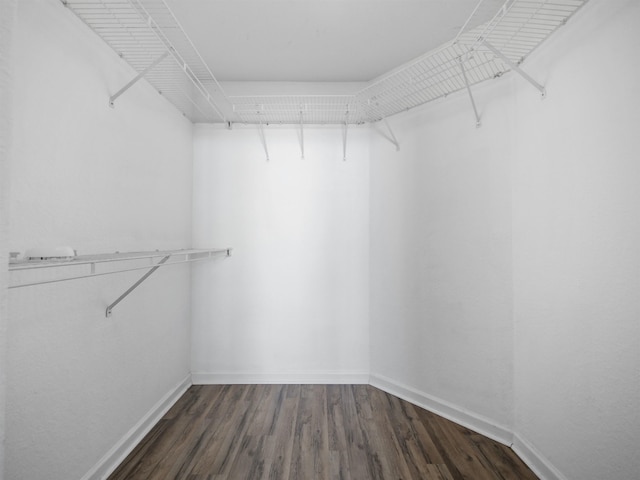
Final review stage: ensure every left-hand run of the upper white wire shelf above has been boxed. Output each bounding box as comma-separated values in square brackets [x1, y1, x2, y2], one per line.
[63, 0, 234, 123]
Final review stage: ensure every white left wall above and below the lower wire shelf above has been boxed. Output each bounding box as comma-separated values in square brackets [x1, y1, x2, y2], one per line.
[3, 0, 193, 480]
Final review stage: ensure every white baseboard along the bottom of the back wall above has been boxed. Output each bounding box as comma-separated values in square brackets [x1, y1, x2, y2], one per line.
[191, 372, 369, 385]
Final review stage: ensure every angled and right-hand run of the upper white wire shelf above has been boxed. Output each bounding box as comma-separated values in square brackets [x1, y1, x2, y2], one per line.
[356, 0, 587, 122]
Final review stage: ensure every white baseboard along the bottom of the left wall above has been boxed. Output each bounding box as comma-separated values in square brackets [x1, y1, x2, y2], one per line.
[81, 375, 192, 480]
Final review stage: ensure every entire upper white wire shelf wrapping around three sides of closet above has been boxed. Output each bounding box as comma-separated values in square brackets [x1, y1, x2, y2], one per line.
[62, 0, 588, 125]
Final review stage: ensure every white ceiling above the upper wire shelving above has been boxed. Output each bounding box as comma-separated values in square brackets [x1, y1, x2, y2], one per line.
[166, 0, 505, 82]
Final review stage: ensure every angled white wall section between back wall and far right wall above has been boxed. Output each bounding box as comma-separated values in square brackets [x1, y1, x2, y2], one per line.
[371, 73, 513, 438]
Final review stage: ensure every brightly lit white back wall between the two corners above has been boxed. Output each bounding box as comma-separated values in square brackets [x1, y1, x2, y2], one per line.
[191, 125, 369, 383]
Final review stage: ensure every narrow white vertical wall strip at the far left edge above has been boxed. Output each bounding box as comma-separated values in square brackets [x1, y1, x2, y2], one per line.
[0, 0, 16, 480]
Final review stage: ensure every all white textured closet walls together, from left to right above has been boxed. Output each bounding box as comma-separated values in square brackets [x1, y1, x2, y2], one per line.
[5, 0, 640, 480]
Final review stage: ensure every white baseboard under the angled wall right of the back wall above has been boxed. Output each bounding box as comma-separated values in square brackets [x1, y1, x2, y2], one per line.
[369, 374, 513, 446]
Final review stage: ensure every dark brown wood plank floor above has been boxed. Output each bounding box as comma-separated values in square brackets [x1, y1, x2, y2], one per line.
[109, 385, 537, 480]
